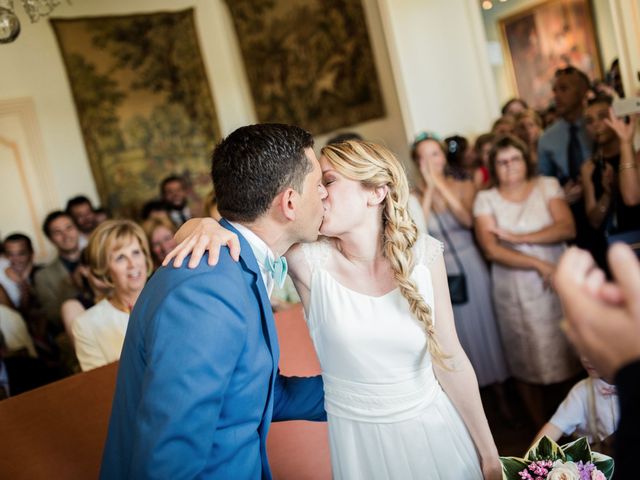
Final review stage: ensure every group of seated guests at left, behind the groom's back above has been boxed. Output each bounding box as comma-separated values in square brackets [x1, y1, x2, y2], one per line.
[0, 176, 200, 398]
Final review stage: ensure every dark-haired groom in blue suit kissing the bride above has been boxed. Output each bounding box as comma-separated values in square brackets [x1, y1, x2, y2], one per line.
[100, 124, 327, 479]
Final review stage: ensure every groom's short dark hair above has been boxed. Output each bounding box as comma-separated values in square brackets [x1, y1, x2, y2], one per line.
[211, 123, 313, 222]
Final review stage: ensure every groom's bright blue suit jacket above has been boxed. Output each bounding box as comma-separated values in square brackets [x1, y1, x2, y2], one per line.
[100, 221, 326, 480]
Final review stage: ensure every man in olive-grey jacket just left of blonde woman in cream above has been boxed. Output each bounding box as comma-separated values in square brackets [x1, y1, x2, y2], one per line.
[34, 211, 80, 333]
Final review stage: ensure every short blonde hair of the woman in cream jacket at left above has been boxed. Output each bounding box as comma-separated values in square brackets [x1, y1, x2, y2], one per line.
[87, 220, 153, 289]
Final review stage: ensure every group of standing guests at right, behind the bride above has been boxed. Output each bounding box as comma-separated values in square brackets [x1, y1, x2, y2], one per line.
[412, 62, 640, 448]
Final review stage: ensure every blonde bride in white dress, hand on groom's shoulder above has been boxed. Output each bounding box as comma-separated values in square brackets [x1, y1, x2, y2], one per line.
[165, 141, 502, 480]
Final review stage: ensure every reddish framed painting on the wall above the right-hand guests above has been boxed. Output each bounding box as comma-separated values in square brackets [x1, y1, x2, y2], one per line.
[499, 0, 602, 109]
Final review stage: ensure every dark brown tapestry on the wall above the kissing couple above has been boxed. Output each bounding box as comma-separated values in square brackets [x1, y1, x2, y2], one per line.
[226, 0, 385, 134]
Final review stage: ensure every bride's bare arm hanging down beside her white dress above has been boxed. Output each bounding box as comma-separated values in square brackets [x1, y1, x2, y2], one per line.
[430, 255, 502, 479]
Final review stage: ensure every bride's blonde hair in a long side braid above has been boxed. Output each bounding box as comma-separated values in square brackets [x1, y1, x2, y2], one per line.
[321, 141, 448, 368]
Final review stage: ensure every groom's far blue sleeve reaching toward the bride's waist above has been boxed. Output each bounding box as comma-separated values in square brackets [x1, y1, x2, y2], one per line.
[273, 371, 327, 422]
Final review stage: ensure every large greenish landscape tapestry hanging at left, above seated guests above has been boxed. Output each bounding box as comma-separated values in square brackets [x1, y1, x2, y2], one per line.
[51, 9, 219, 215]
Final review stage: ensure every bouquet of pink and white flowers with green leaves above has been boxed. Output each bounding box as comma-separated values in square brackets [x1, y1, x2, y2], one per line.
[500, 436, 613, 480]
